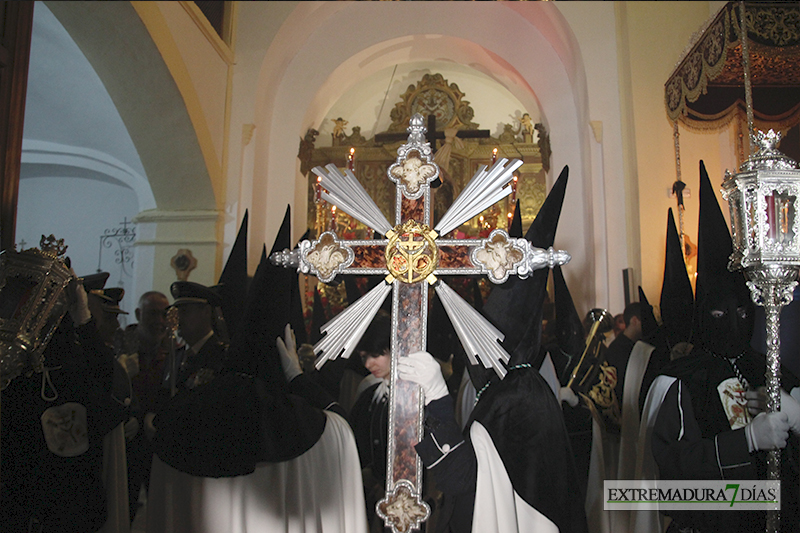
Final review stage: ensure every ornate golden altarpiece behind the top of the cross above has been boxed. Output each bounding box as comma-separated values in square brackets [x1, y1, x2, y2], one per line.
[298, 74, 550, 238]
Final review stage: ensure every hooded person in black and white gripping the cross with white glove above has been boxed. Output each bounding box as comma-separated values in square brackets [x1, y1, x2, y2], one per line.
[398, 164, 587, 533]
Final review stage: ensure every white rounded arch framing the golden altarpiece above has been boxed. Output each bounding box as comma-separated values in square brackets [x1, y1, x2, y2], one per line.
[251, 2, 595, 303]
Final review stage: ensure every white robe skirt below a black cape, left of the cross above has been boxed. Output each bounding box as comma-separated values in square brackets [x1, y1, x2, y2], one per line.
[147, 411, 367, 533]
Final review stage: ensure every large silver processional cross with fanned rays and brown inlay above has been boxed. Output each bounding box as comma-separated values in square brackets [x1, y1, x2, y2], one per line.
[270, 114, 570, 533]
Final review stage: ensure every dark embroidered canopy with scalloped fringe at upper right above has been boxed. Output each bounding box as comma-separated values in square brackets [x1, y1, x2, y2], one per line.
[664, 2, 800, 129]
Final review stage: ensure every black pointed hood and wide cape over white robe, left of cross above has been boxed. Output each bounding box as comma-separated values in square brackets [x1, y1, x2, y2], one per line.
[154, 208, 326, 477]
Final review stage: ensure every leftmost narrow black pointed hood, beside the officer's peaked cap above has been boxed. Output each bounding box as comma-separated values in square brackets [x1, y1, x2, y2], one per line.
[218, 211, 248, 338]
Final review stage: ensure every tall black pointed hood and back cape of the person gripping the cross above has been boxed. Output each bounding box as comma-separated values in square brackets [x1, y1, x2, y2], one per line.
[462, 167, 587, 533]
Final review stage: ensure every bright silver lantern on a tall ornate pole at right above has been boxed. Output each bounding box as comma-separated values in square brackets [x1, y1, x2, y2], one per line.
[722, 130, 800, 531]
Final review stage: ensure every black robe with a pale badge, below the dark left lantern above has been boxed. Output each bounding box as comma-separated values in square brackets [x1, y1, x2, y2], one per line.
[0, 319, 128, 533]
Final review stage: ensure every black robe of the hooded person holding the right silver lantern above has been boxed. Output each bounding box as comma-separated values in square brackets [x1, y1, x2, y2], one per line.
[652, 348, 800, 533]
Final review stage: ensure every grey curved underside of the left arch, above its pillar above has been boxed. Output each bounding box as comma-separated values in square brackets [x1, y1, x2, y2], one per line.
[46, 2, 217, 211]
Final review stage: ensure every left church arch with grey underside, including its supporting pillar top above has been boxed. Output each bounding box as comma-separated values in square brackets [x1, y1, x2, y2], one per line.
[47, 2, 223, 294]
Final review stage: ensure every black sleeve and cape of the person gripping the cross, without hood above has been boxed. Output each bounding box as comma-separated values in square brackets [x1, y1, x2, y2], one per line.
[416, 367, 588, 533]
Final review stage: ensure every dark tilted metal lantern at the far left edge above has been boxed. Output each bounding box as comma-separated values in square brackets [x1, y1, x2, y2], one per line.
[0, 235, 73, 390]
